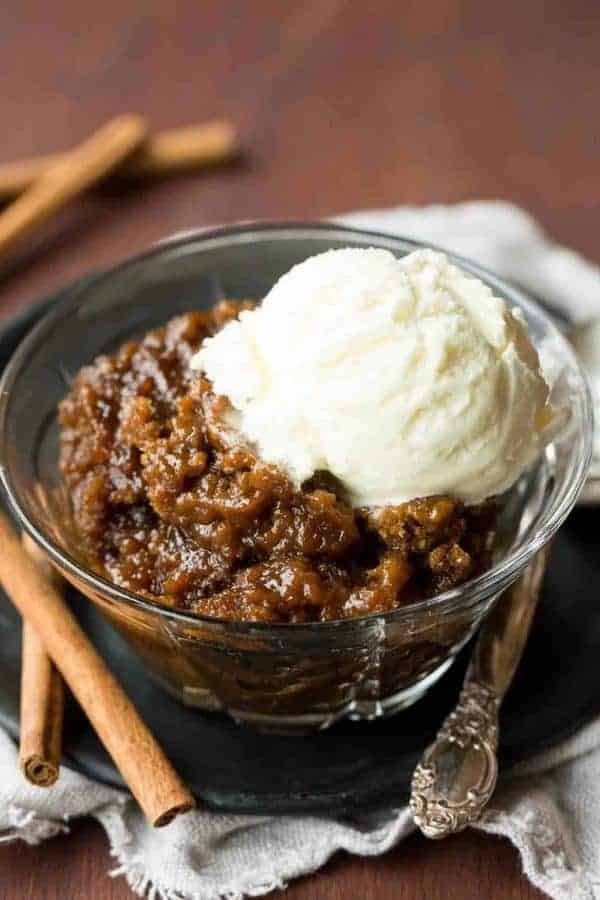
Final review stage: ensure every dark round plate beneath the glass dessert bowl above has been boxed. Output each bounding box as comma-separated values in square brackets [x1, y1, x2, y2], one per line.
[0, 288, 600, 815]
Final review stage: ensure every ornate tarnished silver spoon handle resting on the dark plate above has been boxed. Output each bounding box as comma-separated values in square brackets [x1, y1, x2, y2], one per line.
[410, 546, 549, 838]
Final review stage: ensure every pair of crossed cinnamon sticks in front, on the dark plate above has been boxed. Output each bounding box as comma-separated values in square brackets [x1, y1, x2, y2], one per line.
[0, 513, 194, 827]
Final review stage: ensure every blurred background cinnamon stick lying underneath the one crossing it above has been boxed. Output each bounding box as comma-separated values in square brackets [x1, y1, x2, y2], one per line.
[0, 119, 238, 200]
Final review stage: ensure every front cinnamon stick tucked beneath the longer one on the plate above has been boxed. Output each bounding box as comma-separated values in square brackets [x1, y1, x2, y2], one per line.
[19, 537, 65, 787]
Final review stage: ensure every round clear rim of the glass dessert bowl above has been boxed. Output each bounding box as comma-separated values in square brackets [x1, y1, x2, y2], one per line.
[0, 219, 593, 636]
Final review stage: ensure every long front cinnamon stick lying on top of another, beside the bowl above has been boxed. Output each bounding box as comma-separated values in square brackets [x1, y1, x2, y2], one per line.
[0, 514, 194, 827]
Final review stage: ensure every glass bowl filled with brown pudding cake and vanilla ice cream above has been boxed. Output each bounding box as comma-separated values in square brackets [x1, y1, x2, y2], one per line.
[1, 225, 590, 730]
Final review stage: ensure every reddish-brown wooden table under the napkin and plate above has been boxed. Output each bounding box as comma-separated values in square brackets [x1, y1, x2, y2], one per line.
[0, 0, 600, 900]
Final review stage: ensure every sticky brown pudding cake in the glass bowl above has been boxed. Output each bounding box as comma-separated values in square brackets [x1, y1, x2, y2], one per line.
[60, 301, 495, 622]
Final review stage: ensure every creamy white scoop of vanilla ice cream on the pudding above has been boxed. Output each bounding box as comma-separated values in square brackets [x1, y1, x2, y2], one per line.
[192, 248, 552, 506]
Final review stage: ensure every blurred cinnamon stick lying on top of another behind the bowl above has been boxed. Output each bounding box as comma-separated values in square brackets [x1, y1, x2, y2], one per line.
[0, 115, 146, 254]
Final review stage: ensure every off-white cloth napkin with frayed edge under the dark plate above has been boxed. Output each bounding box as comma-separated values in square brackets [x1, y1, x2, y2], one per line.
[0, 202, 600, 900]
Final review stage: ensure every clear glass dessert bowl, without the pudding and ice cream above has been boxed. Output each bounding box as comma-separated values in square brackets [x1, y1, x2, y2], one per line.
[0, 223, 592, 732]
